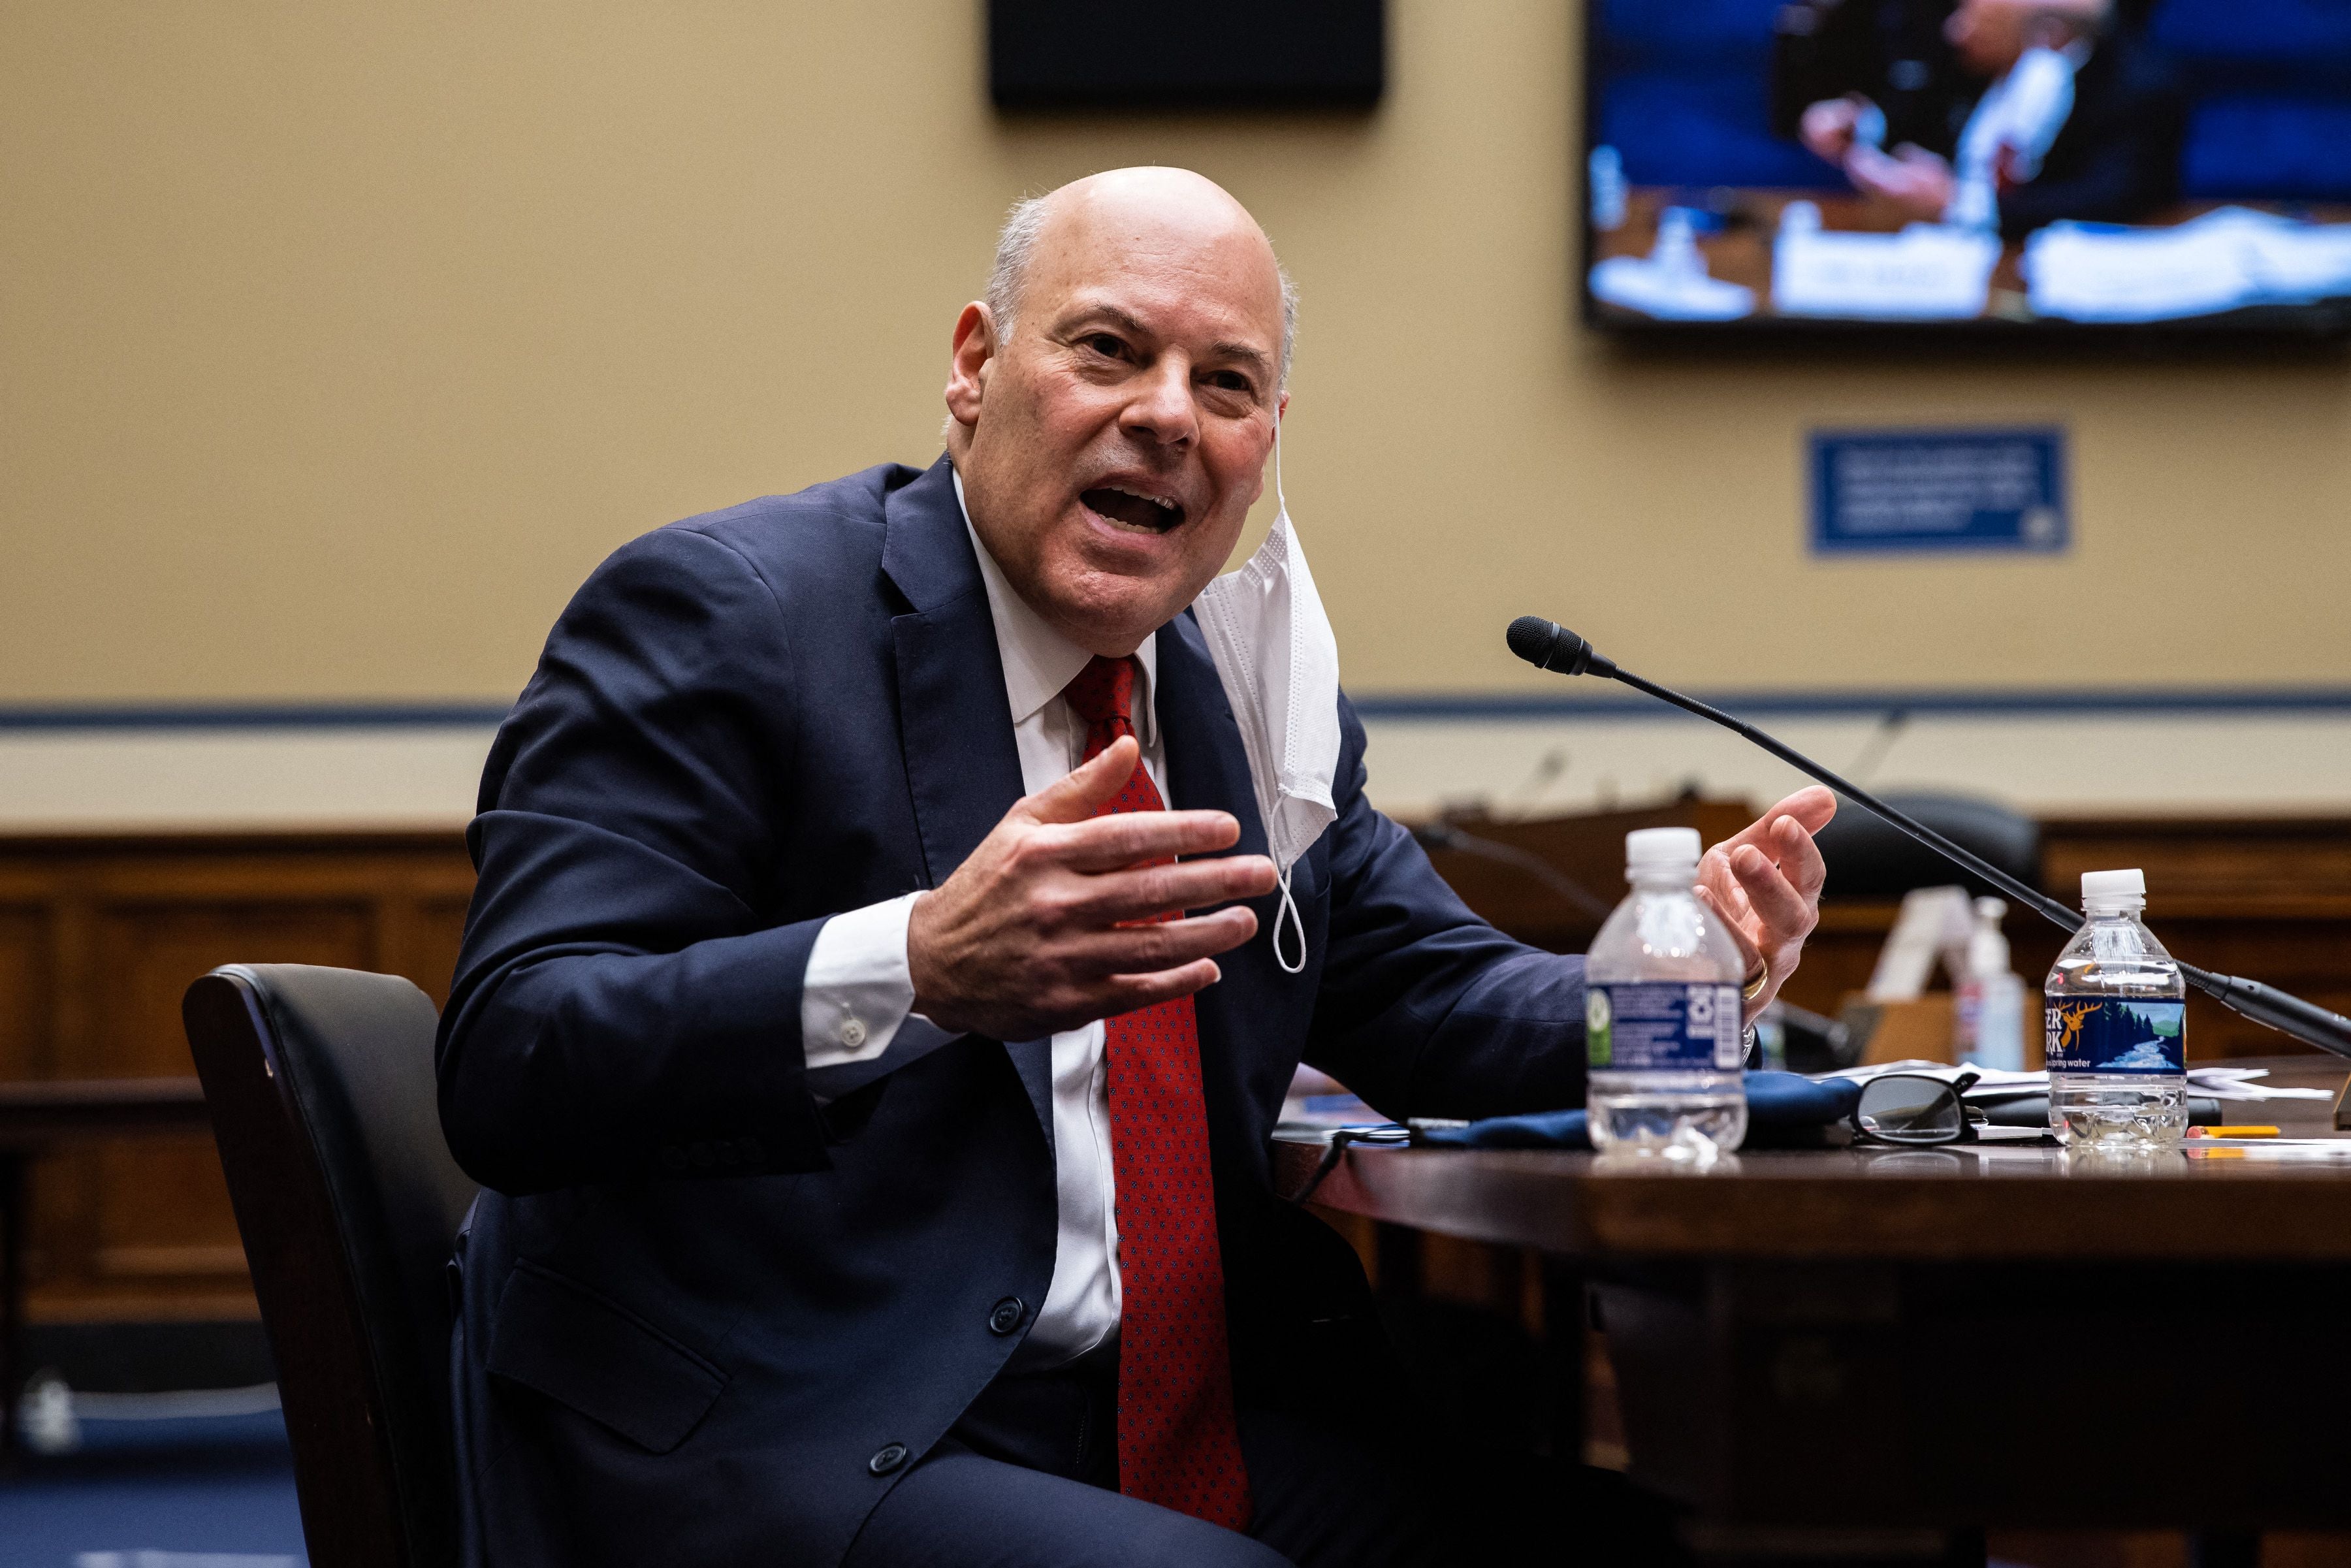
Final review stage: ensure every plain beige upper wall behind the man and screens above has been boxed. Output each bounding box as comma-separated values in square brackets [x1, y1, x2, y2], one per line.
[0, 0, 2351, 705]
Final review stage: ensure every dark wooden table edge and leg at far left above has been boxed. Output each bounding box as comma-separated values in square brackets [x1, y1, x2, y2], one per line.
[0, 1077, 212, 1462]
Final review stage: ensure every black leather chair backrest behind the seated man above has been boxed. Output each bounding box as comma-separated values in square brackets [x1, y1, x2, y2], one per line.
[181, 964, 475, 1568]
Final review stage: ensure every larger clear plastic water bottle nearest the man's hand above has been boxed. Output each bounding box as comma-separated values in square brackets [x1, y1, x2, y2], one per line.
[1584, 827, 1747, 1164]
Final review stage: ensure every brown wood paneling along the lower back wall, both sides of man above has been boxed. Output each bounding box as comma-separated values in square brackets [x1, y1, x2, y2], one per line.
[0, 818, 2351, 1321]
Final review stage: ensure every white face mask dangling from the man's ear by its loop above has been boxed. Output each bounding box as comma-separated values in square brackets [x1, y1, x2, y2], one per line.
[1192, 421, 1337, 976]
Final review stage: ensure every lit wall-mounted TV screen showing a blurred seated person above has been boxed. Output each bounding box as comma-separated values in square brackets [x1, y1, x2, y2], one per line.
[1584, 0, 2351, 336]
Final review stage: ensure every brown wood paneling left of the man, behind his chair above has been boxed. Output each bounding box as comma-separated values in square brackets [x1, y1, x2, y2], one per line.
[0, 835, 473, 1321]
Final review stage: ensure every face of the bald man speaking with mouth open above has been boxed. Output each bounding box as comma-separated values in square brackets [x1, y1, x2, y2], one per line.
[948, 169, 1284, 656]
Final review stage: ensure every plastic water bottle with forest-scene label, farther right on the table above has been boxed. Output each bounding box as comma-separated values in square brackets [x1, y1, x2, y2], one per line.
[2045, 870, 2189, 1147]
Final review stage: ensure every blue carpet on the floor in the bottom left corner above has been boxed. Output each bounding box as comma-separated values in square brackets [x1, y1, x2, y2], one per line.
[0, 1411, 306, 1568]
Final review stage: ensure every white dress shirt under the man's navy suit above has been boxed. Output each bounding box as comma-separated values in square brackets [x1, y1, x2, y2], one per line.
[799, 475, 1166, 1368]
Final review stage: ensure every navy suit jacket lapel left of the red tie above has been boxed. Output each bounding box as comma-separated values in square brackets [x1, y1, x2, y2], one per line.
[882, 458, 1053, 1145]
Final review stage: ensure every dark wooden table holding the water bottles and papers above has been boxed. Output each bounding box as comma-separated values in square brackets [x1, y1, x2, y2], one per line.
[1277, 1058, 2351, 1561]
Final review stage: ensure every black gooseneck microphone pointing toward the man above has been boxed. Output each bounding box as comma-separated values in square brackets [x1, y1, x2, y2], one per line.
[1509, 616, 2351, 1055]
